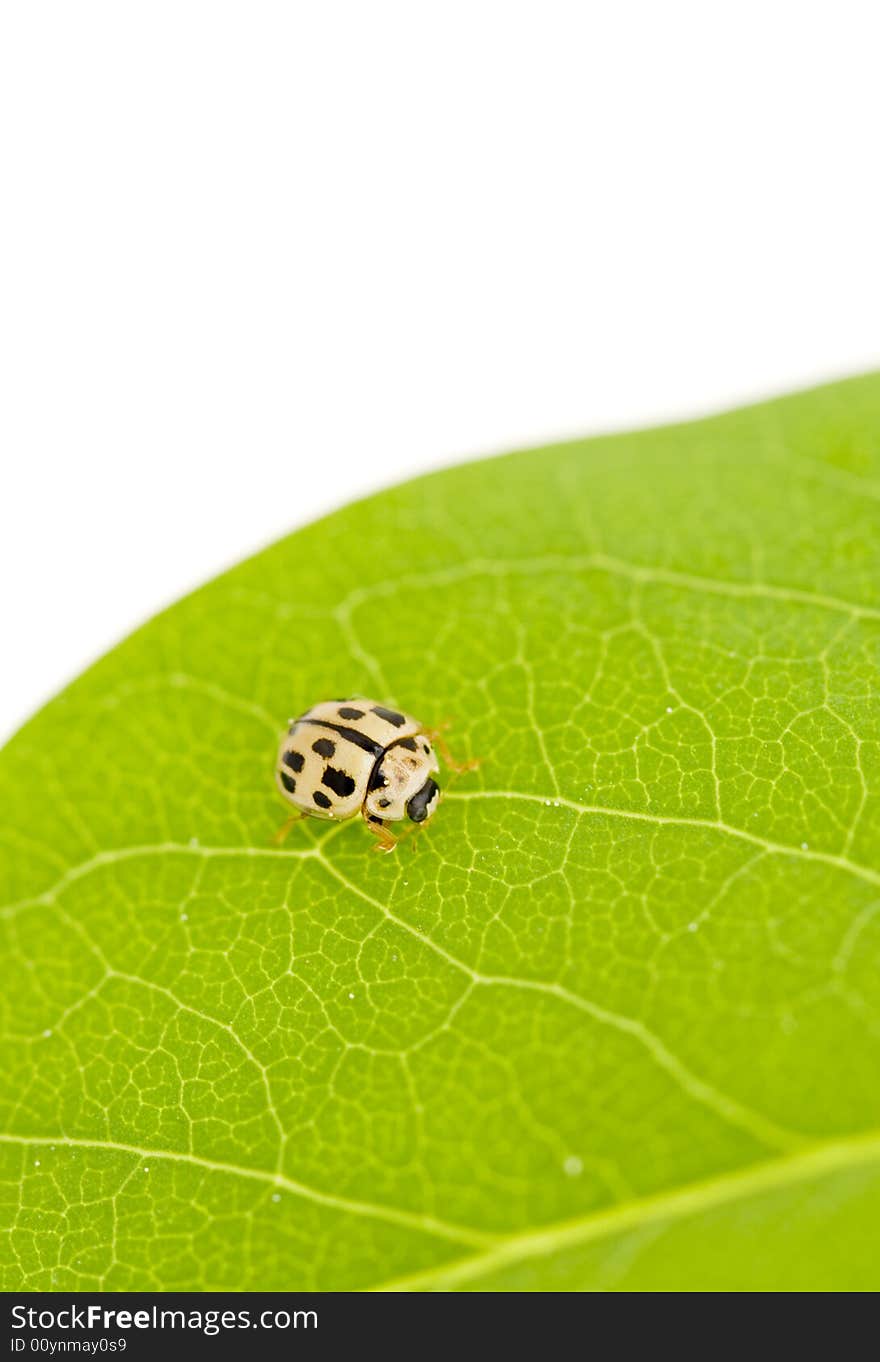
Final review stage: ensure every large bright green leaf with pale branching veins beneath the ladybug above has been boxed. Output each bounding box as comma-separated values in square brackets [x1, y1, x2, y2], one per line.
[0, 376, 880, 1291]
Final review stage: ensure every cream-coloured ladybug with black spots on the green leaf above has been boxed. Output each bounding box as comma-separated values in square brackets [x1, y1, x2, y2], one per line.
[275, 697, 477, 851]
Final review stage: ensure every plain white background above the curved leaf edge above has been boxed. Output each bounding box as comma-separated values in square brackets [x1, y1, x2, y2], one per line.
[0, 0, 880, 737]
